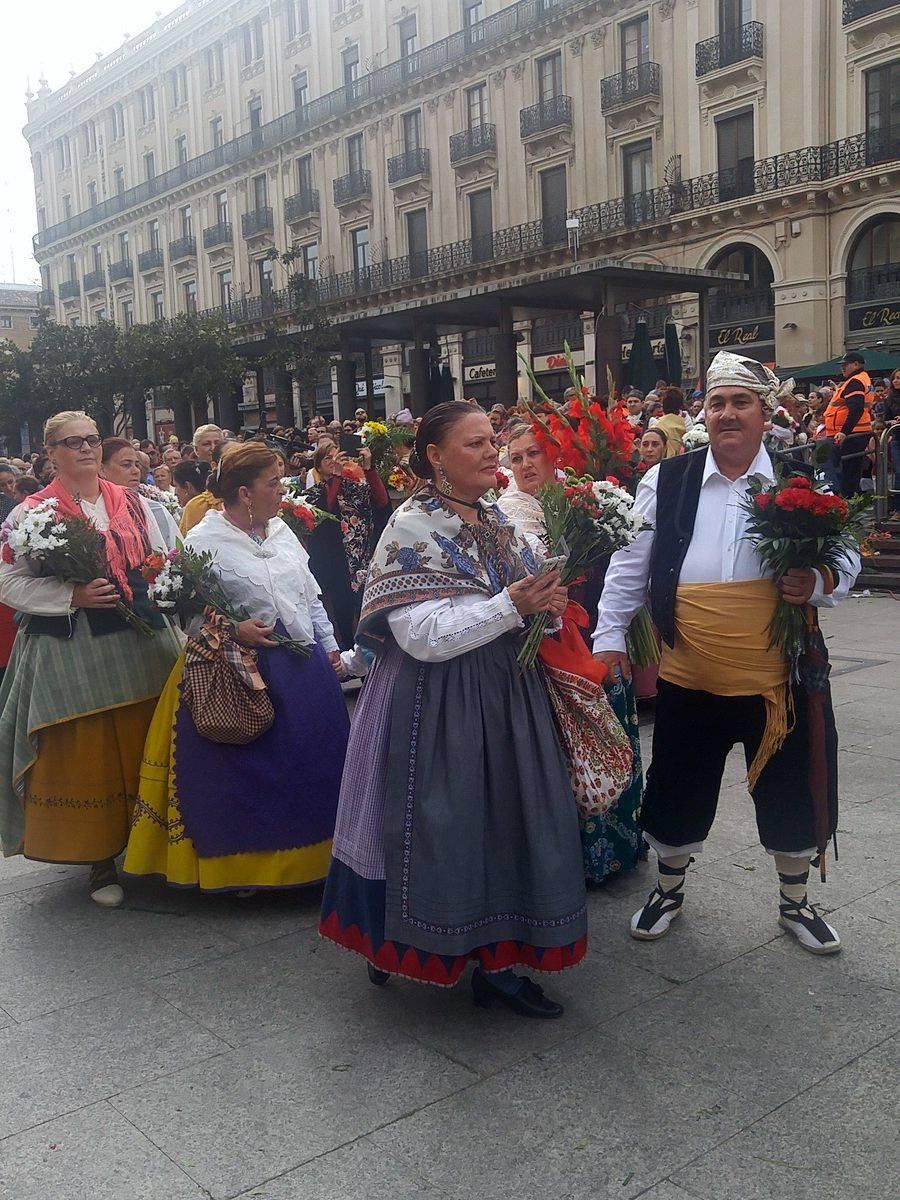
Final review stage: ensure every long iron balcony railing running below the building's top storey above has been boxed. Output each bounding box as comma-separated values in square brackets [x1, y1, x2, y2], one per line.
[34, 0, 584, 250]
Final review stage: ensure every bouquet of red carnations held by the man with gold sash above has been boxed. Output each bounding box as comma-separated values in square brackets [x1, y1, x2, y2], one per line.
[744, 475, 871, 676]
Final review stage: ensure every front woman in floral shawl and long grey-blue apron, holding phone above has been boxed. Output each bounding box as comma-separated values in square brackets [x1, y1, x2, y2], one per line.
[320, 401, 587, 1018]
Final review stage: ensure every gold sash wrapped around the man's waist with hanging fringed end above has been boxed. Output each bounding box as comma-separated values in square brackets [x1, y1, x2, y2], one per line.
[659, 580, 793, 791]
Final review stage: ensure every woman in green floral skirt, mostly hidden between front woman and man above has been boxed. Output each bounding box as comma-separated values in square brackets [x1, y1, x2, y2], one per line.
[497, 422, 643, 886]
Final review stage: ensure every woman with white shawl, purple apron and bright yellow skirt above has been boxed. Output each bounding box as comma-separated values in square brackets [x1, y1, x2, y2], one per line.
[125, 442, 349, 892]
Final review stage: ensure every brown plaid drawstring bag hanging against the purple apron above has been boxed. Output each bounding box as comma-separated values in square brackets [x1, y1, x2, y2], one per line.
[181, 610, 275, 745]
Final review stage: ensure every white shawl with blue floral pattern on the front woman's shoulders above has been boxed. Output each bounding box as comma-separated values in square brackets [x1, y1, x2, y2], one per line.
[359, 487, 536, 636]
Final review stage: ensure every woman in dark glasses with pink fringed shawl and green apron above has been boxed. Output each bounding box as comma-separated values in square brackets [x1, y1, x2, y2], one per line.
[0, 412, 179, 908]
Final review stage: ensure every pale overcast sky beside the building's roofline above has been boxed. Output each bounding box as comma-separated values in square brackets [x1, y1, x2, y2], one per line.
[0, 0, 178, 283]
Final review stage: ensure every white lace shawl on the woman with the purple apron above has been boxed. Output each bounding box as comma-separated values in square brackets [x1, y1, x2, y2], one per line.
[185, 511, 337, 653]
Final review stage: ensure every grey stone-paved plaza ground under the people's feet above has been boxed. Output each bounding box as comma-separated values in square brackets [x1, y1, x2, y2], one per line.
[0, 596, 900, 1200]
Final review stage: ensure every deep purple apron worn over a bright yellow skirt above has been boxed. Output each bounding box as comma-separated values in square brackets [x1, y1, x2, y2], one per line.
[174, 644, 349, 858]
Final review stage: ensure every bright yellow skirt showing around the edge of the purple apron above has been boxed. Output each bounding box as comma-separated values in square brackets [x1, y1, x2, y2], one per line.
[125, 655, 331, 892]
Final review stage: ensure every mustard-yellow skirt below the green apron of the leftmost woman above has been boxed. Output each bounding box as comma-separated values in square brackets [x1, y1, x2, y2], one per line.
[22, 700, 156, 863]
